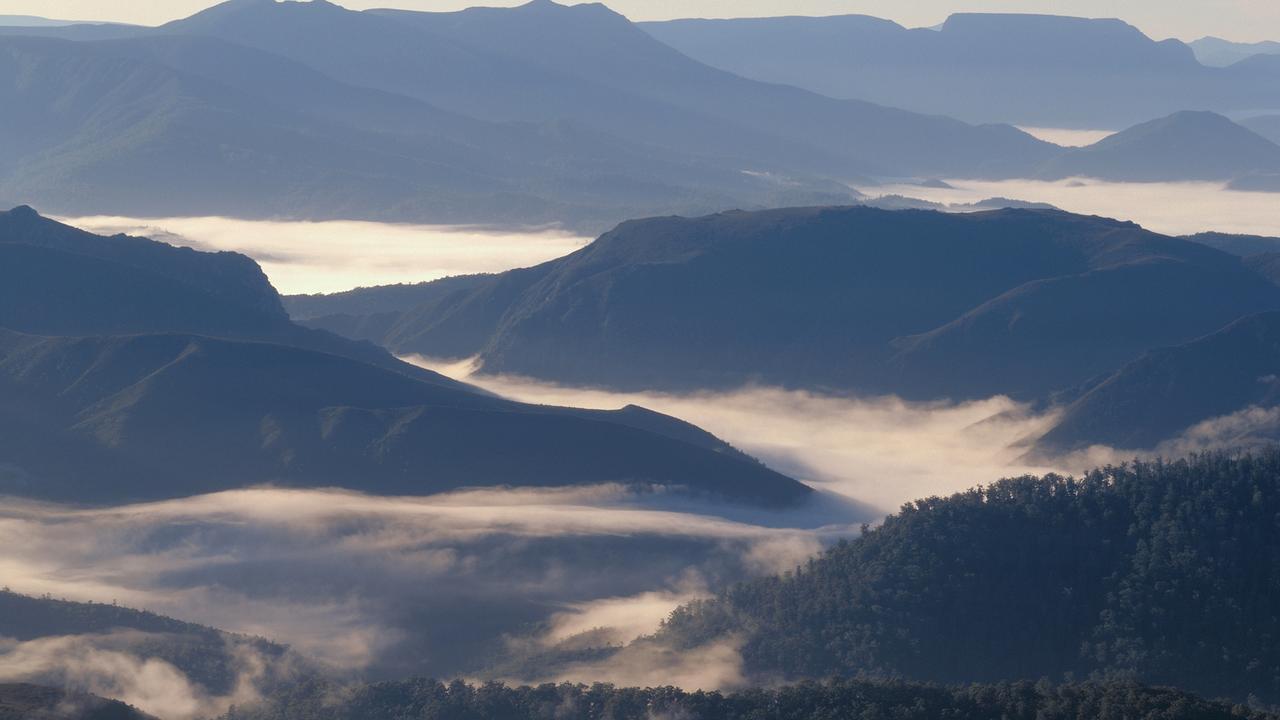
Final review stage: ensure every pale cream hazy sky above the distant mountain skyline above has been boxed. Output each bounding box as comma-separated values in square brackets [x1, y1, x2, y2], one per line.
[0, 0, 1280, 41]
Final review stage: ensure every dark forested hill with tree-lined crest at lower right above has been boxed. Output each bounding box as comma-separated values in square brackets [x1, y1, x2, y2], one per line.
[659, 450, 1280, 703]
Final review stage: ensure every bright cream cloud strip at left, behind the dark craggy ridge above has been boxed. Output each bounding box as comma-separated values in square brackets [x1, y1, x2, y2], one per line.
[52, 215, 589, 295]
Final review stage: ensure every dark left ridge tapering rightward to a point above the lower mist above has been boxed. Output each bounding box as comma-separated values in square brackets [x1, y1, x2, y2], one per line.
[0, 333, 808, 505]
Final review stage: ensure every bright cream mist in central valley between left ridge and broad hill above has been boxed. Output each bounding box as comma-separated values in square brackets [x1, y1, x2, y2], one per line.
[407, 356, 1064, 514]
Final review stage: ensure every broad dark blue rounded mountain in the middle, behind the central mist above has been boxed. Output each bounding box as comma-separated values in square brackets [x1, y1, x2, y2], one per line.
[300, 208, 1280, 397]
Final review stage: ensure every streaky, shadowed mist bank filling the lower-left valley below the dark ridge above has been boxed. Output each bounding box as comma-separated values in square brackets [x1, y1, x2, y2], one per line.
[0, 484, 829, 692]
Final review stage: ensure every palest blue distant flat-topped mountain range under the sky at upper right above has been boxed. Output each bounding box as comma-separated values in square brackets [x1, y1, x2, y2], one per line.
[641, 13, 1280, 128]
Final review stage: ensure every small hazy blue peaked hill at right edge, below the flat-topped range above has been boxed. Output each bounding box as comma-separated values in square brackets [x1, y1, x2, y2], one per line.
[1039, 111, 1280, 182]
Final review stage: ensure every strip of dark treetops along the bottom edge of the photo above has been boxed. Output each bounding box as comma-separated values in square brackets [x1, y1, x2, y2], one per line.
[224, 680, 1275, 720]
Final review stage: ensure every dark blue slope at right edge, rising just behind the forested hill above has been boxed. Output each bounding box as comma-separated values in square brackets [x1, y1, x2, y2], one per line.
[1037, 313, 1280, 452]
